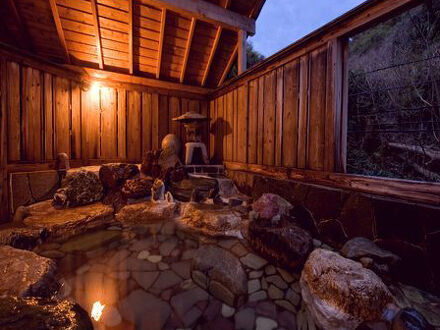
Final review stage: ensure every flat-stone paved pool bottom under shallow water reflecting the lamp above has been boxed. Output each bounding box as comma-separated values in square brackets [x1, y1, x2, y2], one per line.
[36, 221, 315, 330]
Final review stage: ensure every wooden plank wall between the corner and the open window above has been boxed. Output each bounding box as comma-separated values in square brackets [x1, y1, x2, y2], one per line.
[210, 42, 335, 172]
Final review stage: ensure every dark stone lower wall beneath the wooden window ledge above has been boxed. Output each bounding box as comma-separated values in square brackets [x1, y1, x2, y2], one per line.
[228, 171, 440, 293]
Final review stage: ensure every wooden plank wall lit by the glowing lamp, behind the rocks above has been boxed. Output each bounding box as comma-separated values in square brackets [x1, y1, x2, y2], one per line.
[0, 61, 208, 167]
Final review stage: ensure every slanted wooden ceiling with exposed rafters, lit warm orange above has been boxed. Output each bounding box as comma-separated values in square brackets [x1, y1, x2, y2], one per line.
[0, 0, 264, 87]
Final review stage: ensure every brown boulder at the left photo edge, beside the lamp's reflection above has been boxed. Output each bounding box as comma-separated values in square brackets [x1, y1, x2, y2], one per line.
[0, 246, 59, 298]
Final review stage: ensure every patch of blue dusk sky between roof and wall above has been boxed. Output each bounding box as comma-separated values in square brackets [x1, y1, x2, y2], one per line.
[248, 0, 364, 57]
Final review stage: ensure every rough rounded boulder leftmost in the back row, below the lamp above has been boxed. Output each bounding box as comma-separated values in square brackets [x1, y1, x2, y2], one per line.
[53, 170, 104, 207]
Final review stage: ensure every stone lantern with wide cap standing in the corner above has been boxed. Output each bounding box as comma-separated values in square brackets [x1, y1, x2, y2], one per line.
[173, 111, 209, 165]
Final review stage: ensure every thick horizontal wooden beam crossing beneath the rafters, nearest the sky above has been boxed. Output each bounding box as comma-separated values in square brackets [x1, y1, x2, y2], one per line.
[140, 0, 255, 35]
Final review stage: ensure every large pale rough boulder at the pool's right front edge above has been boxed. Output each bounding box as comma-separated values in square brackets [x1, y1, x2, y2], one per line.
[300, 249, 393, 330]
